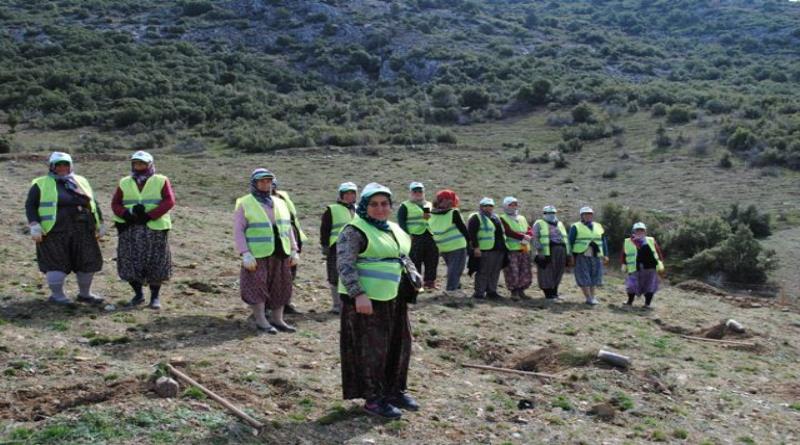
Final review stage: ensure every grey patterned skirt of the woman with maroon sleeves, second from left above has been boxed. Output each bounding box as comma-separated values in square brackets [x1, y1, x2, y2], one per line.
[117, 224, 172, 284]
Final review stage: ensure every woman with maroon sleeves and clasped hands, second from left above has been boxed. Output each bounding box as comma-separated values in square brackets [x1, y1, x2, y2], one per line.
[111, 151, 175, 310]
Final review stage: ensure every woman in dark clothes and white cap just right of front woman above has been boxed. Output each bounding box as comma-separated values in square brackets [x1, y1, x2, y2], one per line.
[397, 182, 439, 290]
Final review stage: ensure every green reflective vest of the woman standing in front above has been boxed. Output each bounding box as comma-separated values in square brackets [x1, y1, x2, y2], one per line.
[339, 216, 411, 301]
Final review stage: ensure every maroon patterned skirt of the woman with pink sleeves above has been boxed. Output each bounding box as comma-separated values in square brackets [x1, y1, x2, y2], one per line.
[239, 255, 292, 309]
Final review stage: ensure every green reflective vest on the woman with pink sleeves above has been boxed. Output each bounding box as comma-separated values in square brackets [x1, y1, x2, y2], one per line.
[236, 194, 292, 258]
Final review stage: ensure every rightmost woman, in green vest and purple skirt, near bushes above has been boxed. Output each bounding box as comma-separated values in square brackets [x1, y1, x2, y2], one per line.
[621, 222, 664, 308]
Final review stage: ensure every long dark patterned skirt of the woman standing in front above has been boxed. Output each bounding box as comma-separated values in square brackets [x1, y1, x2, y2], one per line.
[339, 295, 411, 400]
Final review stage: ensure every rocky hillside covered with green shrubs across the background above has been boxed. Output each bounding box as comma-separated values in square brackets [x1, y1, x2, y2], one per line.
[0, 0, 800, 169]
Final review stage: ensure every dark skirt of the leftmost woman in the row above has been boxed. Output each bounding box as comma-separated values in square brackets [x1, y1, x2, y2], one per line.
[36, 213, 103, 273]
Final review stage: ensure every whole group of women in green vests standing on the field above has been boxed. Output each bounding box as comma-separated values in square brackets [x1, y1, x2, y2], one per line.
[26, 151, 663, 418]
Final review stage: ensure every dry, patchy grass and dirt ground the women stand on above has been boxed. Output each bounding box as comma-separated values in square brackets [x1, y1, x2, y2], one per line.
[0, 131, 800, 444]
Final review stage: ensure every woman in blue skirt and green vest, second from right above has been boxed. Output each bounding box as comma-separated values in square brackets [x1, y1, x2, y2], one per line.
[568, 207, 608, 305]
